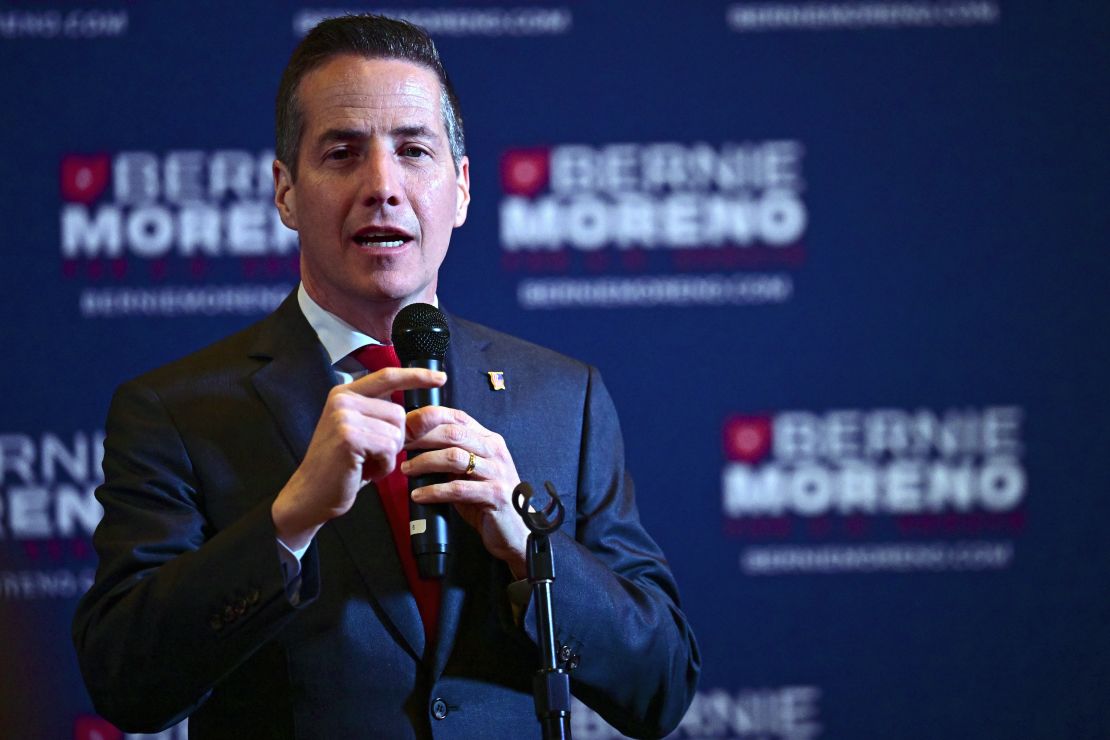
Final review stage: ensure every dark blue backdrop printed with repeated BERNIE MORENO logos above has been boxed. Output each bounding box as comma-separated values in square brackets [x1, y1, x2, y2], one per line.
[0, 0, 1110, 740]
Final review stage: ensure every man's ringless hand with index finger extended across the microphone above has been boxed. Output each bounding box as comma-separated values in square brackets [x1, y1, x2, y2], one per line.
[270, 367, 447, 550]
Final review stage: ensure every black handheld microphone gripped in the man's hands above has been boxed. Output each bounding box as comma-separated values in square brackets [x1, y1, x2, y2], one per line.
[392, 303, 451, 578]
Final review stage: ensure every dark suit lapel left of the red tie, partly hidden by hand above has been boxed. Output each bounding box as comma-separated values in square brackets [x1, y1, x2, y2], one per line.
[251, 292, 424, 659]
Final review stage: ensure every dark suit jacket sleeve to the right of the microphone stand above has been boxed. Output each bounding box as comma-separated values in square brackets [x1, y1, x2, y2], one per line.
[523, 367, 700, 737]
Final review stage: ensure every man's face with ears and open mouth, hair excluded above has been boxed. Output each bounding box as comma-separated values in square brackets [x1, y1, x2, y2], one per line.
[274, 55, 470, 338]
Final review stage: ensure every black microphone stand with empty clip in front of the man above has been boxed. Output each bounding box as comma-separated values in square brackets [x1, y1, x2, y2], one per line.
[513, 481, 571, 740]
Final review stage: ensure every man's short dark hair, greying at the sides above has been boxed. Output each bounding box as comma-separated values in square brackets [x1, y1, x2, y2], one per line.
[281, 13, 466, 180]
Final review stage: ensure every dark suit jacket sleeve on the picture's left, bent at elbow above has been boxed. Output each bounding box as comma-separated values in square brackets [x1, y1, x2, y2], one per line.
[73, 382, 319, 732]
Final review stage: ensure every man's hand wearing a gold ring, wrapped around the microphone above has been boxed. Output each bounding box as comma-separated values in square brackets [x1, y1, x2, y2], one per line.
[401, 406, 528, 579]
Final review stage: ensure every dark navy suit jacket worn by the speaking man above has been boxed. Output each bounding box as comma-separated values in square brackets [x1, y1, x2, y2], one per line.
[73, 295, 699, 739]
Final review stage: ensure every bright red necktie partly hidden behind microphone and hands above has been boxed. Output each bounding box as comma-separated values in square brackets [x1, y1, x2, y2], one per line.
[351, 344, 441, 645]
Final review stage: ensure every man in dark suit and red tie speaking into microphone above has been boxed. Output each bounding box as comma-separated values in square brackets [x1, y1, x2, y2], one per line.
[74, 17, 699, 738]
